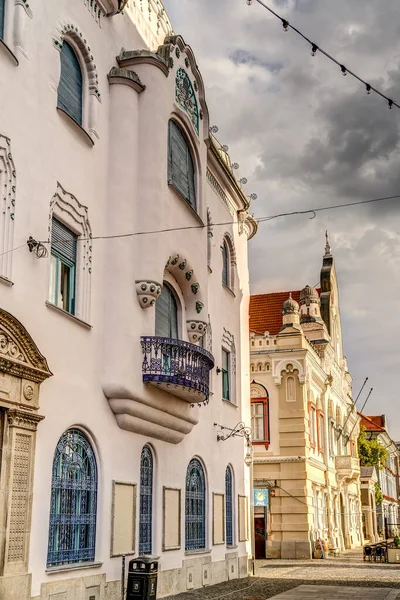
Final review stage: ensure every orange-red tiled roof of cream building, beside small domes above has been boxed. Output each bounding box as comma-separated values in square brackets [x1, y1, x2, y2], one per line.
[250, 290, 300, 335]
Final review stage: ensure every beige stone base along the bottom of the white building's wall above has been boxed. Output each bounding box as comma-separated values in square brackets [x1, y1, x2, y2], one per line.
[30, 552, 249, 600]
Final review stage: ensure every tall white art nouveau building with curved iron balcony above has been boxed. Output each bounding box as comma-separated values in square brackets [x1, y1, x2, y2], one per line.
[0, 0, 257, 600]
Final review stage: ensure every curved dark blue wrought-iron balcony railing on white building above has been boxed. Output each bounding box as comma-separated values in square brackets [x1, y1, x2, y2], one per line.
[141, 337, 214, 403]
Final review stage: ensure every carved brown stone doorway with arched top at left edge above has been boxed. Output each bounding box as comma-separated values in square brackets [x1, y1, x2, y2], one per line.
[0, 308, 52, 600]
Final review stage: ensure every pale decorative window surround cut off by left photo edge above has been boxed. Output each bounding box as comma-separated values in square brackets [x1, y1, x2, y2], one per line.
[0, 135, 17, 281]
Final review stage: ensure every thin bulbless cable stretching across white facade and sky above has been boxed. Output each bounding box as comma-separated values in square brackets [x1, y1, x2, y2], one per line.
[0, 194, 400, 257]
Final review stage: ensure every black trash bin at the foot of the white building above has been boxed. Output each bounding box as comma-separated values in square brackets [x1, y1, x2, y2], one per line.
[126, 556, 158, 600]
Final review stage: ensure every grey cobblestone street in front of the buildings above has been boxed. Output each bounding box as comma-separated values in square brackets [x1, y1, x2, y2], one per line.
[166, 550, 400, 600]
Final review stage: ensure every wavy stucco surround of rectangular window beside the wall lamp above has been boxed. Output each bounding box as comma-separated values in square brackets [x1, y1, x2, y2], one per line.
[48, 183, 92, 323]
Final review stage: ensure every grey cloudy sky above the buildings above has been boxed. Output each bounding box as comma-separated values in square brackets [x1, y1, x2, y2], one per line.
[164, 0, 400, 439]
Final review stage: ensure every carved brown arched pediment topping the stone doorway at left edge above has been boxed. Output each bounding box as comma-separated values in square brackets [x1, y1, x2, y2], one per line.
[0, 308, 52, 383]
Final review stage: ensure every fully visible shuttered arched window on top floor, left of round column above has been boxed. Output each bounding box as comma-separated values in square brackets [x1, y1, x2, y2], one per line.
[57, 40, 83, 125]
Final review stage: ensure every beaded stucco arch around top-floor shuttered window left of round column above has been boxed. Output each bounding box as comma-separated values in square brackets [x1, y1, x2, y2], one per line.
[53, 23, 101, 138]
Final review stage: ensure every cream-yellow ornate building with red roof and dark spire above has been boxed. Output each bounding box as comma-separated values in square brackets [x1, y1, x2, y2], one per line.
[250, 241, 363, 558]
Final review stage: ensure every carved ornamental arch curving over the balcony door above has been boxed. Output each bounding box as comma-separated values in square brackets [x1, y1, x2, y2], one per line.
[165, 254, 207, 341]
